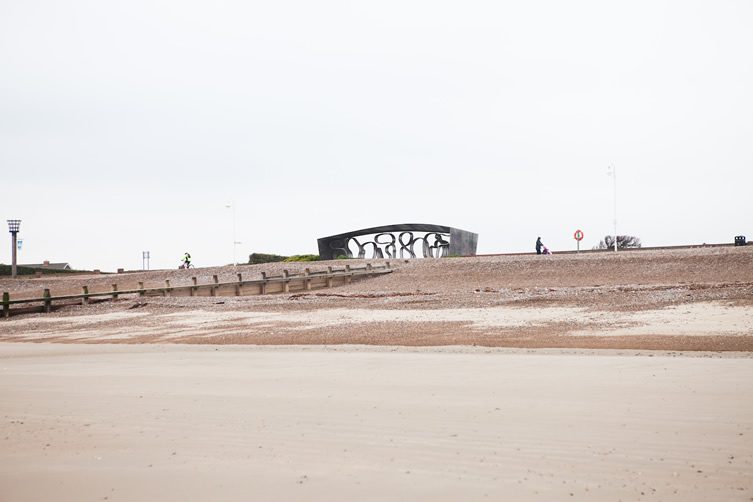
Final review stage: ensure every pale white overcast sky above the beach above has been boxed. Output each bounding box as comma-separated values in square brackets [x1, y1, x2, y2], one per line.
[0, 0, 753, 270]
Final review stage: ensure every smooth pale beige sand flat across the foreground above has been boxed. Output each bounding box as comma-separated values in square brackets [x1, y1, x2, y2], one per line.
[0, 343, 753, 501]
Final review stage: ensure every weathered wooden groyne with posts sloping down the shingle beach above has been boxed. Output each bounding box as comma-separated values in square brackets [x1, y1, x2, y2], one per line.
[2, 262, 392, 317]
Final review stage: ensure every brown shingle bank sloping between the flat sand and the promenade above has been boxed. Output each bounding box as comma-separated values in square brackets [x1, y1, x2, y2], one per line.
[0, 246, 753, 351]
